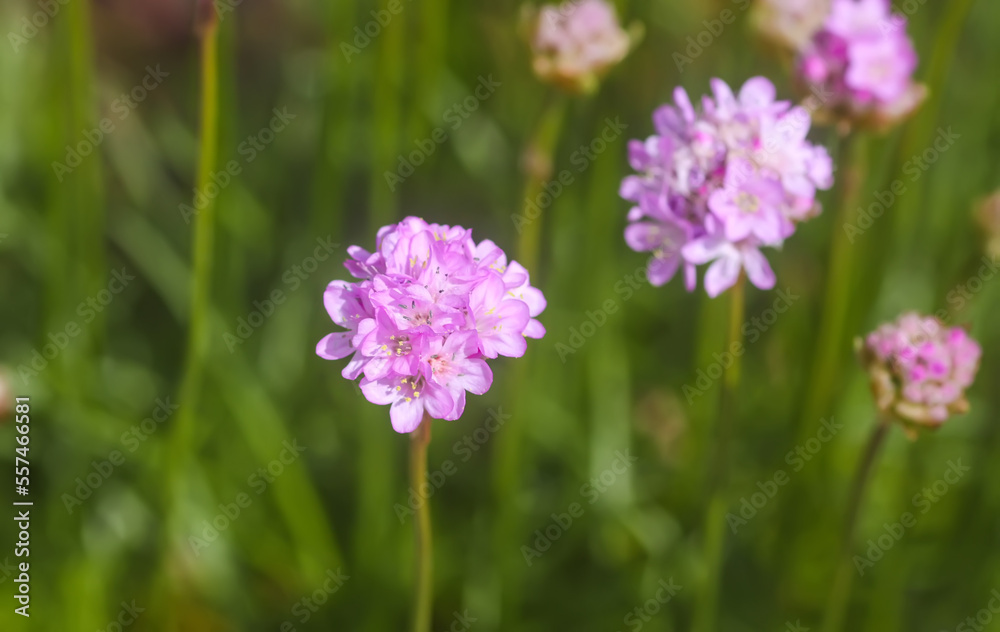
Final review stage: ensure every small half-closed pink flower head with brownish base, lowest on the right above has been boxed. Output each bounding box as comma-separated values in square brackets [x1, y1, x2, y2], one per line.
[858, 312, 981, 431]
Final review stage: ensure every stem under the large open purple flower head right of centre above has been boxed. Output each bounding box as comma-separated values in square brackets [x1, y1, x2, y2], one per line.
[692, 273, 746, 632]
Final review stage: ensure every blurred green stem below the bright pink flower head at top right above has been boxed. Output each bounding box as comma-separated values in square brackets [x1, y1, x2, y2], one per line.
[801, 135, 868, 446]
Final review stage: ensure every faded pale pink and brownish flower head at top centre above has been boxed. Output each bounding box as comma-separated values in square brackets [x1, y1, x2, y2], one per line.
[529, 0, 631, 93]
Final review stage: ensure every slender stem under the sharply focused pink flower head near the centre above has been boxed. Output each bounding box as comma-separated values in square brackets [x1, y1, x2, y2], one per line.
[410, 413, 434, 632]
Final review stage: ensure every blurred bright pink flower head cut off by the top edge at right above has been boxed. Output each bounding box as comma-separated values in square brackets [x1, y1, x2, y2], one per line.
[797, 0, 927, 128]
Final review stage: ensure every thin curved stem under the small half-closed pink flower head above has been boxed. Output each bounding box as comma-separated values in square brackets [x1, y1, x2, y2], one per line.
[823, 416, 890, 632]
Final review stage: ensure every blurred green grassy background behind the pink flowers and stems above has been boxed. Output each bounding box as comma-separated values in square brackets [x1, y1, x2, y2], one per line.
[0, 0, 1000, 632]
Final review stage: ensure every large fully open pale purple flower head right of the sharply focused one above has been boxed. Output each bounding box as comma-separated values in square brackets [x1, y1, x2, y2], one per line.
[621, 77, 833, 297]
